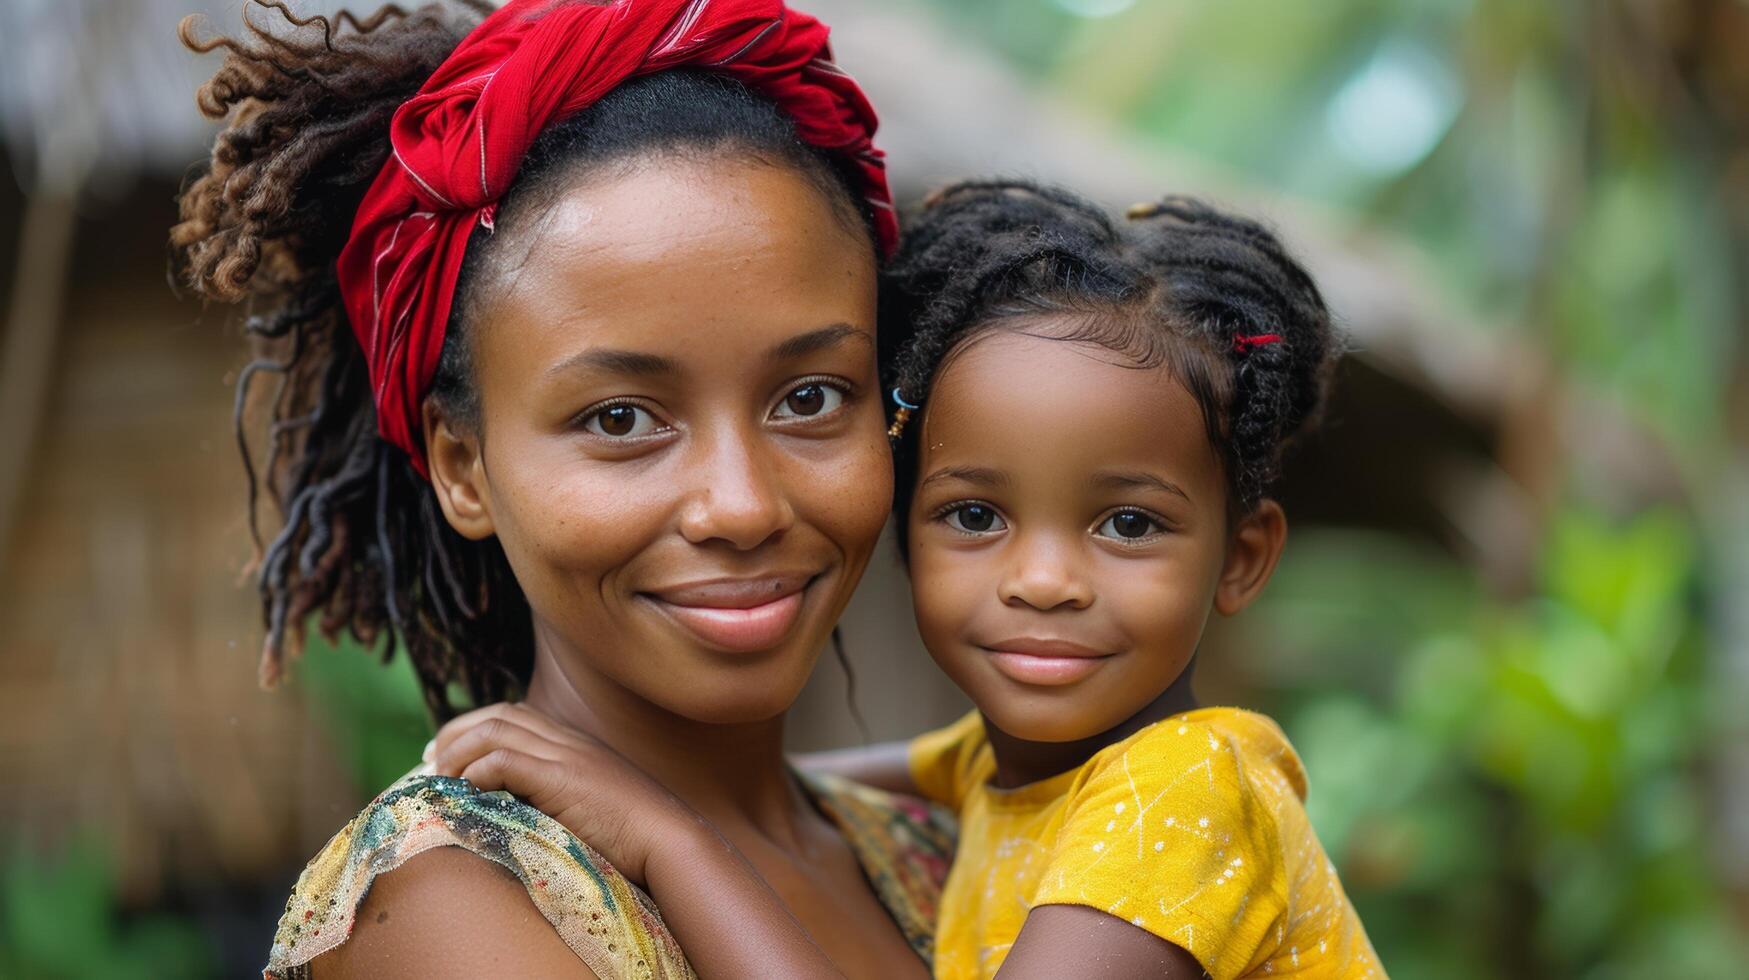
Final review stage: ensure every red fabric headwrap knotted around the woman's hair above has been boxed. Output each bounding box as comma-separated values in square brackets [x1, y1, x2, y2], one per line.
[339, 0, 899, 476]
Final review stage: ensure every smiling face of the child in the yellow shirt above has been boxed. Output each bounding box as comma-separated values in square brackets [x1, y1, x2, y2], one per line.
[908, 320, 1245, 742]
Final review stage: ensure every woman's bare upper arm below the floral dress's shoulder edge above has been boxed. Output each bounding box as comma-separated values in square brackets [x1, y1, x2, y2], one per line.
[310, 847, 595, 980]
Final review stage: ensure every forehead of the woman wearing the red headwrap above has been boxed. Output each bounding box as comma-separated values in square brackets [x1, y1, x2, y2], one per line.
[476, 159, 875, 369]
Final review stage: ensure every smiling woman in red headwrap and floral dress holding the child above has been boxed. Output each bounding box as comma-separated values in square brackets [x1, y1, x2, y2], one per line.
[173, 0, 946, 978]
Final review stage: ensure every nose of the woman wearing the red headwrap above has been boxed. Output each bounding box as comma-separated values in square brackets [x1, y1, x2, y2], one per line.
[680, 423, 796, 551]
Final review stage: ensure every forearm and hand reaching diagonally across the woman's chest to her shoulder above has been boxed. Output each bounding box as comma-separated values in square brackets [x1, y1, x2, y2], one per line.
[430, 704, 841, 980]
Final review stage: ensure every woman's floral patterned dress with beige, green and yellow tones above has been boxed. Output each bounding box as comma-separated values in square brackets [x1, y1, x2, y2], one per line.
[262, 772, 953, 980]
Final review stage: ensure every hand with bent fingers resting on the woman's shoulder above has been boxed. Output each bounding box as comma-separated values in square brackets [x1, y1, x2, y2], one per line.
[427, 704, 703, 886]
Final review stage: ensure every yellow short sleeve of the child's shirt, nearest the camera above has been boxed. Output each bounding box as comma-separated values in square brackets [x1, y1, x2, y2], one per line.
[1034, 719, 1287, 980]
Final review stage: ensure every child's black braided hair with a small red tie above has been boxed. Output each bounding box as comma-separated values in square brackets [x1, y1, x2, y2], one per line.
[880, 180, 1341, 542]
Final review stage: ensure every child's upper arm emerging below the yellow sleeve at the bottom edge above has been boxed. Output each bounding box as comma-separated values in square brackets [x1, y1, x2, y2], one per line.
[995, 905, 1207, 980]
